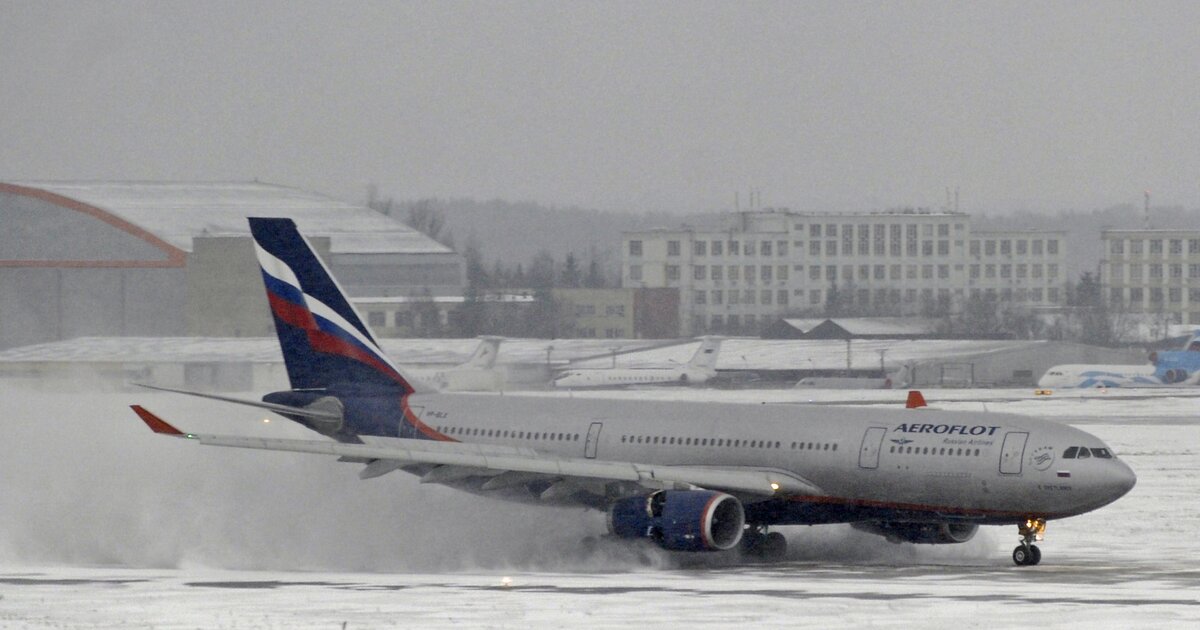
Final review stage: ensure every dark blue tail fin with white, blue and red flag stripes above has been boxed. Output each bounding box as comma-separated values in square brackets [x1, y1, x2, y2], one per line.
[250, 218, 427, 395]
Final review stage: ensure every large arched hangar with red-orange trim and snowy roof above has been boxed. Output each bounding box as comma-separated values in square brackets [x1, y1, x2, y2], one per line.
[0, 181, 467, 348]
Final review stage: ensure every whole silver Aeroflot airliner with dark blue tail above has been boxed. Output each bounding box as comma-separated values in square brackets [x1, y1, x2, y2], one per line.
[133, 218, 1136, 565]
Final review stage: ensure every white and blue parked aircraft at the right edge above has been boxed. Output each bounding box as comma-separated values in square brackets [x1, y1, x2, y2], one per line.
[1038, 332, 1200, 388]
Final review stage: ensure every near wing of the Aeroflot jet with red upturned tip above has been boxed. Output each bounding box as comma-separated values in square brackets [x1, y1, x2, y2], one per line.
[132, 404, 823, 498]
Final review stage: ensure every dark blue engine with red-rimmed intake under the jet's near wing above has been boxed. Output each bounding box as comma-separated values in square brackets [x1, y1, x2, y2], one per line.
[608, 490, 745, 551]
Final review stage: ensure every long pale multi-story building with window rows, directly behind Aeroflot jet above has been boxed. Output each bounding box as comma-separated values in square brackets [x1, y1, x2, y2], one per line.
[622, 209, 1067, 334]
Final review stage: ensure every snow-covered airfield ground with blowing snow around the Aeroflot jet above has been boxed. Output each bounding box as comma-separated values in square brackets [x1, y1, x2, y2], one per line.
[0, 386, 1200, 629]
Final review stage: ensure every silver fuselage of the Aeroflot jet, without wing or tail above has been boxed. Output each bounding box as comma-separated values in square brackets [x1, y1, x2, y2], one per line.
[398, 394, 1134, 524]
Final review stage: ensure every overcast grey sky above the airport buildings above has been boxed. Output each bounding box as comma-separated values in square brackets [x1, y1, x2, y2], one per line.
[0, 0, 1200, 211]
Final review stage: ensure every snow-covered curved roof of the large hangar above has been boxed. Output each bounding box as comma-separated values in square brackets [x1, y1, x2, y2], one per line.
[8, 181, 451, 253]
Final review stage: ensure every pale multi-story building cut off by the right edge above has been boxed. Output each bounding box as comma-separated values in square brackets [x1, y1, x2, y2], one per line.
[1100, 229, 1200, 324]
